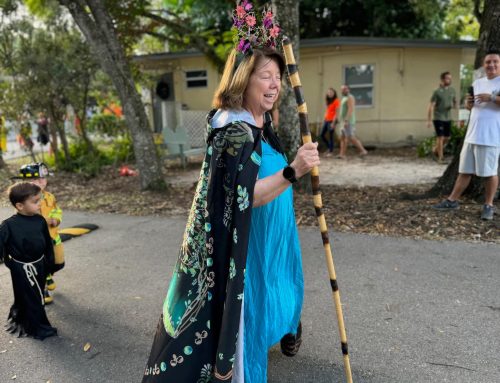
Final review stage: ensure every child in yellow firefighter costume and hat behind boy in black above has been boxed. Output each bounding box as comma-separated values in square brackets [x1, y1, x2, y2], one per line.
[17, 162, 64, 304]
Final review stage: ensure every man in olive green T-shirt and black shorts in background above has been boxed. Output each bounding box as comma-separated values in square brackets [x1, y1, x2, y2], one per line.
[427, 72, 457, 162]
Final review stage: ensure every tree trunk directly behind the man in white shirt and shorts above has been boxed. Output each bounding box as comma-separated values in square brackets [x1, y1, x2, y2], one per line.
[426, 0, 500, 200]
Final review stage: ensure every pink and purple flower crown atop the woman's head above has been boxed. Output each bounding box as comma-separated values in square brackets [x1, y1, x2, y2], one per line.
[233, 0, 281, 54]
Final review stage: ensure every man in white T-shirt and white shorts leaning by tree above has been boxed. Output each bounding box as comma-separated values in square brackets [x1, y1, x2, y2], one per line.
[433, 51, 500, 220]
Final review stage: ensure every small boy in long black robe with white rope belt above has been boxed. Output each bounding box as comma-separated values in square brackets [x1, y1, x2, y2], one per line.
[0, 182, 57, 340]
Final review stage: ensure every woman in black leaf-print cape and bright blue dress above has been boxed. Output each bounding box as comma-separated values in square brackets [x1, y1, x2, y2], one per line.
[143, 5, 319, 383]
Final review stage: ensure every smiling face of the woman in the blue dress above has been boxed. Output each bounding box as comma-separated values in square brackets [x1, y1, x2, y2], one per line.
[243, 58, 281, 116]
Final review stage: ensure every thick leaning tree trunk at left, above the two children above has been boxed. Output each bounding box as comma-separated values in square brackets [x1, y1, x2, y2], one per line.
[59, 0, 165, 189]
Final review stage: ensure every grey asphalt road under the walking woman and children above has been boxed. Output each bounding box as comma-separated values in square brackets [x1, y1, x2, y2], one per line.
[0, 209, 500, 383]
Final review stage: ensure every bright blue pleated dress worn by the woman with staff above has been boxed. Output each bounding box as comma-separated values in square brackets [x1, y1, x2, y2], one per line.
[243, 142, 304, 383]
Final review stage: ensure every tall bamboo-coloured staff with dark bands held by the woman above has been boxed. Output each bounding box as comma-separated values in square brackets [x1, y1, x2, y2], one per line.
[283, 37, 352, 383]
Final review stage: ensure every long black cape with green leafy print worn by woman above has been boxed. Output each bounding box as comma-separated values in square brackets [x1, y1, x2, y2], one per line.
[142, 111, 262, 383]
